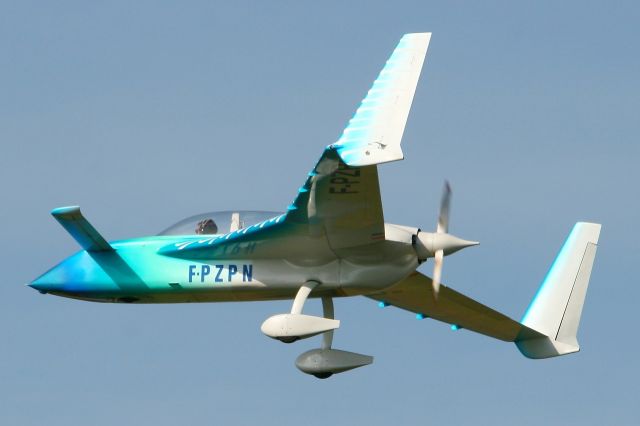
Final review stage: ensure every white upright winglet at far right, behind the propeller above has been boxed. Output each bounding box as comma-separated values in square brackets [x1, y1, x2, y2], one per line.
[515, 222, 601, 358]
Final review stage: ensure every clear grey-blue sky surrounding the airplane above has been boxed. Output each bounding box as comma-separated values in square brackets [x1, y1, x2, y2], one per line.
[0, 0, 640, 425]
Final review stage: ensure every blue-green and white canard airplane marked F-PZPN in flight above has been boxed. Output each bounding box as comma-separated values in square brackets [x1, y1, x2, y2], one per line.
[28, 33, 601, 379]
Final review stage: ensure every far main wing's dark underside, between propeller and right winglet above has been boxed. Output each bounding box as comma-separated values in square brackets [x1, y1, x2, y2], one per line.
[367, 271, 544, 342]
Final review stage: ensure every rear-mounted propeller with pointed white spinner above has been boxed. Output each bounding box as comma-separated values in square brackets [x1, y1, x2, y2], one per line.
[416, 181, 480, 300]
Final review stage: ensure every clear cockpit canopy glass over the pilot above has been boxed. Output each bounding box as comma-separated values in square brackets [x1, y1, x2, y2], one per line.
[158, 210, 281, 235]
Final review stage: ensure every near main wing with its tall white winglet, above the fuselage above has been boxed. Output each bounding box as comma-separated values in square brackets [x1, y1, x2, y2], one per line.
[161, 33, 431, 258]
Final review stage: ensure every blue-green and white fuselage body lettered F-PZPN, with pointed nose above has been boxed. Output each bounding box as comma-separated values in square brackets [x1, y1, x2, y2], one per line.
[36, 224, 418, 303]
